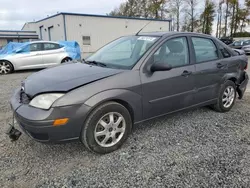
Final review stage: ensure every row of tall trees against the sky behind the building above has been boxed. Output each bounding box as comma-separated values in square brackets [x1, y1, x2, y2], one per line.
[109, 0, 250, 37]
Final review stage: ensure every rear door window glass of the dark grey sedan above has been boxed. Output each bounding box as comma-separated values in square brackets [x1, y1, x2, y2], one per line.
[192, 37, 219, 63]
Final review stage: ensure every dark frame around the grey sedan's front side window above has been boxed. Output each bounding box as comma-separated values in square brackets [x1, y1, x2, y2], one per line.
[145, 35, 192, 71]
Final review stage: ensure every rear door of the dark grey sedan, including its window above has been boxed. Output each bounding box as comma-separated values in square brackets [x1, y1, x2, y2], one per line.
[191, 37, 228, 104]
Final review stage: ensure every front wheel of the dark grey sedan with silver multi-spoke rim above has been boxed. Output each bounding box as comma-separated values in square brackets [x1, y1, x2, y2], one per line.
[80, 102, 132, 154]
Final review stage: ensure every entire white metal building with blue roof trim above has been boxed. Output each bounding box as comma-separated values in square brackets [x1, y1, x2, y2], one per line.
[22, 13, 171, 54]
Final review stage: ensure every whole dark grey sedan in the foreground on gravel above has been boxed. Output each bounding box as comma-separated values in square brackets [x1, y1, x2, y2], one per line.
[8, 32, 248, 154]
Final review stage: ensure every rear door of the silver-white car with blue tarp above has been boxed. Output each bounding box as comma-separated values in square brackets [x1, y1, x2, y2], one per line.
[42, 42, 63, 67]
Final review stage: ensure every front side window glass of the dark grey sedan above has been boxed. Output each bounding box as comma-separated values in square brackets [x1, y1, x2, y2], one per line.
[154, 37, 189, 67]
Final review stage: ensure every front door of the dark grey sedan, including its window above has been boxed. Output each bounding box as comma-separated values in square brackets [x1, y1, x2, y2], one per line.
[141, 37, 195, 119]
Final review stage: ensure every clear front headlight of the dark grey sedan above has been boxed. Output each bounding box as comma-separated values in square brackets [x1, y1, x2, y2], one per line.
[29, 93, 64, 110]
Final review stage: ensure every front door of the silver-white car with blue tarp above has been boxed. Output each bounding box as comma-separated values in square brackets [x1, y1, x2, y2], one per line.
[15, 43, 43, 69]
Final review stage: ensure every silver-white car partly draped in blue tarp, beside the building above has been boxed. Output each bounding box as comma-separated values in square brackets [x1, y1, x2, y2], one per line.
[0, 41, 81, 74]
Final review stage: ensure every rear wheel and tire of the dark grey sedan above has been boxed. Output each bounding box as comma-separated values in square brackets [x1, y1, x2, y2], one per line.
[212, 80, 237, 112]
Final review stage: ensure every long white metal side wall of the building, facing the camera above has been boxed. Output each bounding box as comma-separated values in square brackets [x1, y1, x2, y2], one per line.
[65, 15, 169, 54]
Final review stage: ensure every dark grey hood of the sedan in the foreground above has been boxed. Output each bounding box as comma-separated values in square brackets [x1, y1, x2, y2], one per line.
[24, 63, 124, 97]
